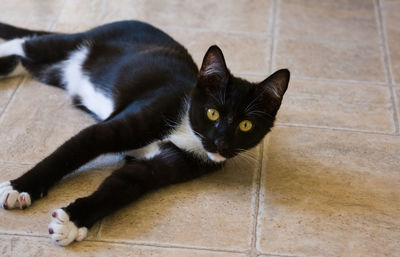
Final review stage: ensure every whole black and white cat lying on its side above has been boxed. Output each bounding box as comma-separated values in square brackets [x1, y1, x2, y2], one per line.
[0, 21, 290, 245]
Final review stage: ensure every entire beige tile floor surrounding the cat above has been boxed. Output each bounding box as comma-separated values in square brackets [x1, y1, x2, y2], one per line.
[0, 0, 400, 257]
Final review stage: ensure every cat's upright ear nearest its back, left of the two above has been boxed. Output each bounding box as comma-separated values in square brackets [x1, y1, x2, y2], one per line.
[199, 45, 229, 90]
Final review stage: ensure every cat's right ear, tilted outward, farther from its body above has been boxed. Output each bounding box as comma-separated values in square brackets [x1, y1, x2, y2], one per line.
[256, 69, 290, 111]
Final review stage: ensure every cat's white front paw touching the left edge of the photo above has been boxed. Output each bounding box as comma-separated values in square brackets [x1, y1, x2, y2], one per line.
[0, 181, 31, 209]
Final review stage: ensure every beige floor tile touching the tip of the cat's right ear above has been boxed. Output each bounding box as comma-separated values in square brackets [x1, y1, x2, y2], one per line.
[274, 38, 386, 82]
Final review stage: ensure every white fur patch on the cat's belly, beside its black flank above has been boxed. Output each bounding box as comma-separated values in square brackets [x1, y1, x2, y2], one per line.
[63, 47, 114, 120]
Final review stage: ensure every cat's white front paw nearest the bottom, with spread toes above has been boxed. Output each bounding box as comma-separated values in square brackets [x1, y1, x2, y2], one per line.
[49, 209, 88, 246]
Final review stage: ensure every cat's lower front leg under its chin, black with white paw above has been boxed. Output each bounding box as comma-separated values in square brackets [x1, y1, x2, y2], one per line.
[48, 144, 220, 246]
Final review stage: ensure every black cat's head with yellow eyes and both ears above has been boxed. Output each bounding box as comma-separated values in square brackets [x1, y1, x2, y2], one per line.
[189, 46, 290, 162]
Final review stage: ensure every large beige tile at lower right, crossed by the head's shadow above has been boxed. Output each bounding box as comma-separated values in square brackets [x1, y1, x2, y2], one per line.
[257, 127, 400, 256]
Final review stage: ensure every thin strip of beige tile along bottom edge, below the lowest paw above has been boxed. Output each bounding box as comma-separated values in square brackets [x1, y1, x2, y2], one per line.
[11, 237, 245, 257]
